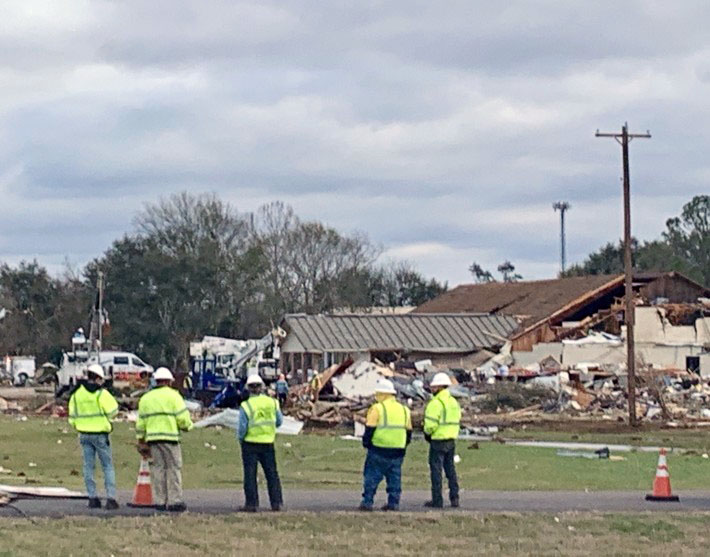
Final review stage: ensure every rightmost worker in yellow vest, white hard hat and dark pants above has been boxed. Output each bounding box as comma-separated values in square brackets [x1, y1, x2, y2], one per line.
[424, 373, 461, 508]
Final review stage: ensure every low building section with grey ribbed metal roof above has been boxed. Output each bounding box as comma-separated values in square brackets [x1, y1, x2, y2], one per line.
[281, 313, 518, 372]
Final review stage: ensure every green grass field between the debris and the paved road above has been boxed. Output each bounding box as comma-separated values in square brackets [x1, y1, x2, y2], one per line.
[0, 416, 710, 490]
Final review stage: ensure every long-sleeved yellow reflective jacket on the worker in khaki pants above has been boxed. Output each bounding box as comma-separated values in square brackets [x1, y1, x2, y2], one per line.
[136, 386, 192, 443]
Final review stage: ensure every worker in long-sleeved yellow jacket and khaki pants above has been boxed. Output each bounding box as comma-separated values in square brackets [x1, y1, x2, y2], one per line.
[136, 367, 192, 512]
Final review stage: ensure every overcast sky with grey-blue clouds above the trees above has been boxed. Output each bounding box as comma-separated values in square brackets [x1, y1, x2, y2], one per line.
[0, 0, 710, 285]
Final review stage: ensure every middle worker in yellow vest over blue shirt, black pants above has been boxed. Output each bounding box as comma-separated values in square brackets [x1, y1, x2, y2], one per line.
[237, 374, 283, 513]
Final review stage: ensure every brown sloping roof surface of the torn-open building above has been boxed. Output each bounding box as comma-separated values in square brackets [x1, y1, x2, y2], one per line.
[414, 275, 623, 325]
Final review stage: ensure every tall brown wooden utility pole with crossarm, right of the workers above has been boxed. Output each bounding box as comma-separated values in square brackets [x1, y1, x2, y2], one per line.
[596, 124, 651, 427]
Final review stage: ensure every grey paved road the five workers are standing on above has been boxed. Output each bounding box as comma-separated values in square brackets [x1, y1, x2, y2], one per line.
[0, 488, 710, 517]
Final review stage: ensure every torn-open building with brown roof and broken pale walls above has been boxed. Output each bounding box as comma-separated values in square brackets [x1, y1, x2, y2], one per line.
[415, 272, 710, 375]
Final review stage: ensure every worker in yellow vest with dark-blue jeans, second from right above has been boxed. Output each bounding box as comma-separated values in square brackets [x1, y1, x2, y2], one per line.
[359, 379, 412, 511]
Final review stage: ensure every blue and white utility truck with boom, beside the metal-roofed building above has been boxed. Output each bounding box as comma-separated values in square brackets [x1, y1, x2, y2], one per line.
[192, 328, 285, 408]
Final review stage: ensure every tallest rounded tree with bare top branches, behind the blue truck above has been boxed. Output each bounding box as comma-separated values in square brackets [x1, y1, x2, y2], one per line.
[87, 193, 263, 367]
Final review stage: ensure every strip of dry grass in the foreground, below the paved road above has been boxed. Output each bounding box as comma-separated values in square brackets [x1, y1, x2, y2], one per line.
[0, 513, 710, 556]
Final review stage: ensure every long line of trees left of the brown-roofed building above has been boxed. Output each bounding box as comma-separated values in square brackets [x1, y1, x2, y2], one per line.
[0, 192, 447, 367]
